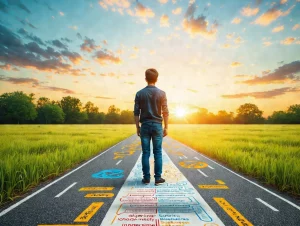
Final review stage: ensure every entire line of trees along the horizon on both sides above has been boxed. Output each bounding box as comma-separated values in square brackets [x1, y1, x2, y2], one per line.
[0, 91, 300, 124]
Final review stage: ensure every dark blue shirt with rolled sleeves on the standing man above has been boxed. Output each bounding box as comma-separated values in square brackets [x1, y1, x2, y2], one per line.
[134, 86, 169, 123]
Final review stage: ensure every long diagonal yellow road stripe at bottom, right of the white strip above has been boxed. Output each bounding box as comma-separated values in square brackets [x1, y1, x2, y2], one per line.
[214, 197, 253, 226]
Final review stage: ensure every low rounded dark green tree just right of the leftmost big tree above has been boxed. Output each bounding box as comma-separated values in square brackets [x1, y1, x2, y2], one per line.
[38, 104, 65, 124]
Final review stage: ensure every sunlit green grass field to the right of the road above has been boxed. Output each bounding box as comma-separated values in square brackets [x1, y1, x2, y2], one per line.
[169, 125, 300, 196]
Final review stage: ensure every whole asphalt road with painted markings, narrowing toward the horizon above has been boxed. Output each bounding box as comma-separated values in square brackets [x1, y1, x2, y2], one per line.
[0, 135, 300, 226]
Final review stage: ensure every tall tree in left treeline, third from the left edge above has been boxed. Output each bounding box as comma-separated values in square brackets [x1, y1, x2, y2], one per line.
[60, 96, 88, 123]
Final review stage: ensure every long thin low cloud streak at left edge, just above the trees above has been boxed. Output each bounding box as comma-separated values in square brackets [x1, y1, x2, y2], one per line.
[0, 75, 75, 94]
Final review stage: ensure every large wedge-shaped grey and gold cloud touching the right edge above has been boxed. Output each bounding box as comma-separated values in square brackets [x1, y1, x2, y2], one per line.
[237, 61, 300, 85]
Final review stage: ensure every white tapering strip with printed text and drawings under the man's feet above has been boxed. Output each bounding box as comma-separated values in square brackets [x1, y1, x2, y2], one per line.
[101, 150, 224, 226]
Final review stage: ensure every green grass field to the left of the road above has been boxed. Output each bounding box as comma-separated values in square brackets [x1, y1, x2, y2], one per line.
[0, 125, 135, 205]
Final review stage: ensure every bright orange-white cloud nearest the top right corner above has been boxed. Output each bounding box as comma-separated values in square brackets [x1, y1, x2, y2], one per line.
[253, 6, 295, 26]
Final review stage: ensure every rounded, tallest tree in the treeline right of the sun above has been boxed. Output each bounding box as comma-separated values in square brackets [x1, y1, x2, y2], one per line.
[235, 103, 264, 124]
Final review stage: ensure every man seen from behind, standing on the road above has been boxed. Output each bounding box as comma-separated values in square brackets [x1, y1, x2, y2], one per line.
[134, 68, 169, 185]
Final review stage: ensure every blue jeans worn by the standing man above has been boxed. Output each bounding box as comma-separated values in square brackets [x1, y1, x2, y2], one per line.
[140, 122, 163, 180]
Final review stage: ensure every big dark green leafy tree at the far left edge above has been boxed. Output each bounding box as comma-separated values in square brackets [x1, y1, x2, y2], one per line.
[0, 91, 37, 123]
